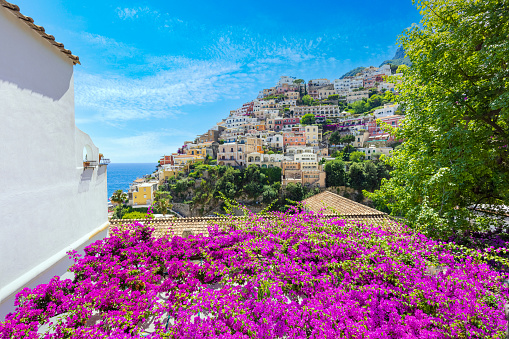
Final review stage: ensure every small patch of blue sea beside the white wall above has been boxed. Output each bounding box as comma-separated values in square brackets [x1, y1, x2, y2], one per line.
[108, 163, 157, 198]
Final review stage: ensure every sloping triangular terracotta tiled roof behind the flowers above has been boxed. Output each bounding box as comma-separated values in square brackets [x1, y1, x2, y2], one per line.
[302, 191, 387, 217]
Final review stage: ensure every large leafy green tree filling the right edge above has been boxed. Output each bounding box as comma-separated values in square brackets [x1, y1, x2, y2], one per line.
[371, 0, 509, 238]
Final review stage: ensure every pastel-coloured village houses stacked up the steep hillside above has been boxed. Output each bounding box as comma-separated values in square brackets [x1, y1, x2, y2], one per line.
[128, 65, 404, 206]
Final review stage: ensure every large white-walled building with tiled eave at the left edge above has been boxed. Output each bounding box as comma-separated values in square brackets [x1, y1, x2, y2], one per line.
[0, 0, 108, 319]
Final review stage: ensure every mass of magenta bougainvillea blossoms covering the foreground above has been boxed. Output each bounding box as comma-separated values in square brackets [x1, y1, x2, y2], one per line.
[0, 211, 509, 338]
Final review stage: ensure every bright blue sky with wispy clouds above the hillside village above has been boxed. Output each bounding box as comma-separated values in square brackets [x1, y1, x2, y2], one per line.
[12, 0, 419, 163]
